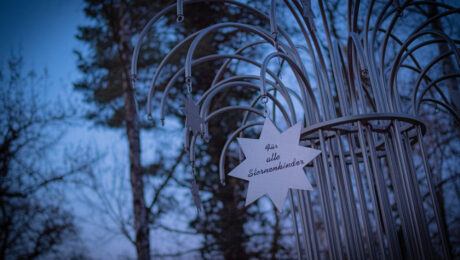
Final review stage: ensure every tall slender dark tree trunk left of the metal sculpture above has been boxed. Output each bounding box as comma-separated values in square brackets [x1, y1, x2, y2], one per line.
[119, 1, 150, 260]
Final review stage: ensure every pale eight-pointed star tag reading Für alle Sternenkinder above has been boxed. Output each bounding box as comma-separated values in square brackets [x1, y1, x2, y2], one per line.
[229, 118, 321, 211]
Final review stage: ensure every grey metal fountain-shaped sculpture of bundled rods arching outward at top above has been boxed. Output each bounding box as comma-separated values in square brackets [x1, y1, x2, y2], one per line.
[131, 0, 460, 259]
